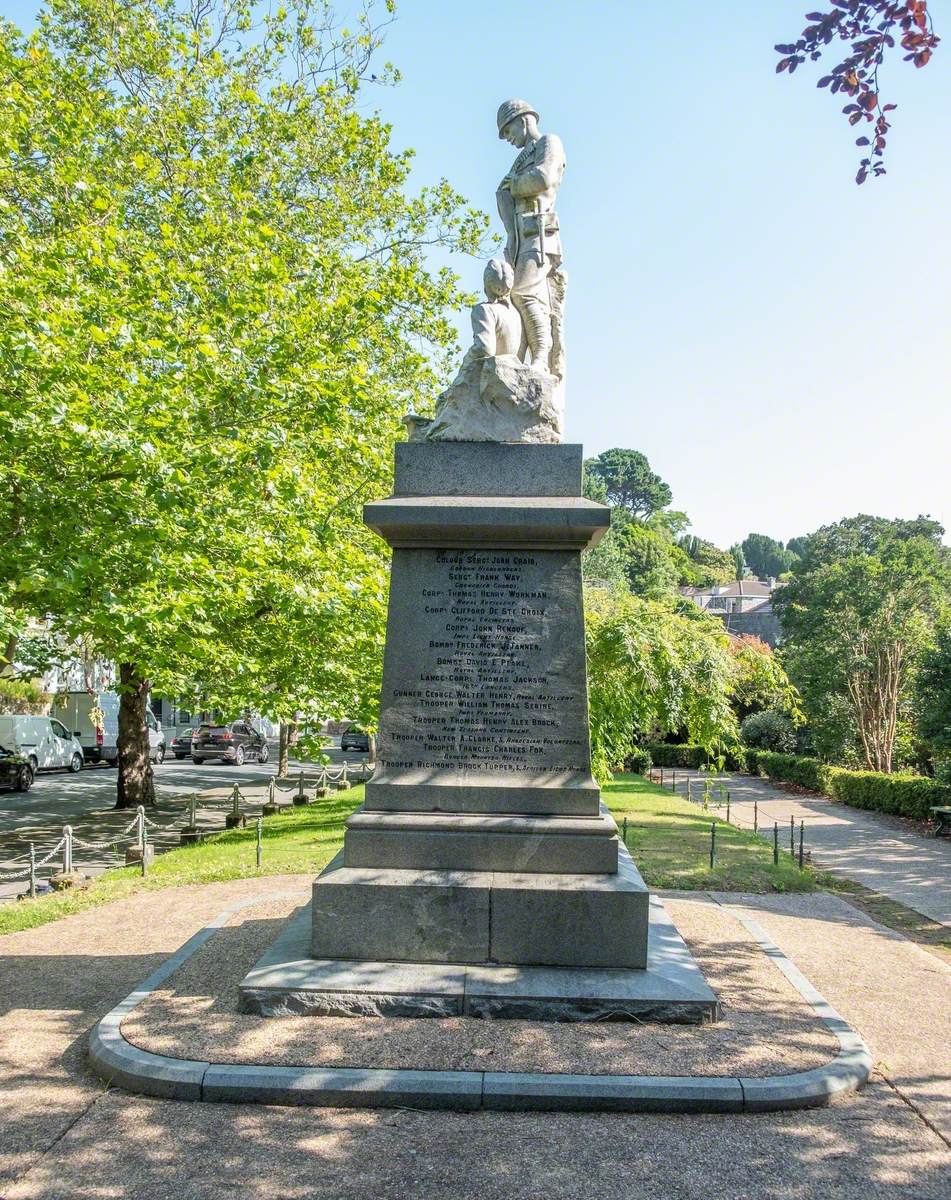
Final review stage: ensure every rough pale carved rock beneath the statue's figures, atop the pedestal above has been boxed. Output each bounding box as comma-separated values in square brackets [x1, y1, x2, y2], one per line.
[409, 352, 562, 444]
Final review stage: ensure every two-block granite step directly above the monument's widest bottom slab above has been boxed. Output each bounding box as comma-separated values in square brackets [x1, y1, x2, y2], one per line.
[311, 834, 648, 968]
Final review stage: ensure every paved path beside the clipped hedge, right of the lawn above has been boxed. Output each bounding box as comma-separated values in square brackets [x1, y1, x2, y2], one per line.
[665, 770, 951, 925]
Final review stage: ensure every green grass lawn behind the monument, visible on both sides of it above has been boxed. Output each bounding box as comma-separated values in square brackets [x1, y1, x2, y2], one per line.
[0, 775, 817, 934]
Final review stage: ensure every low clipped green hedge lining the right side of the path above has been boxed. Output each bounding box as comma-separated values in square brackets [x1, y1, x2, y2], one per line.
[747, 750, 951, 821]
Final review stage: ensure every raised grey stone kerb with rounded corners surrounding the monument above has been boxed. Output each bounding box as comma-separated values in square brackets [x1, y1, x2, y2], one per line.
[89, 892, 872, 1112]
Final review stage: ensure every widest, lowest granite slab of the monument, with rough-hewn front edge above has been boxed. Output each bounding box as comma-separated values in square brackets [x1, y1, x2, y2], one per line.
[240, 896, 719, 1025]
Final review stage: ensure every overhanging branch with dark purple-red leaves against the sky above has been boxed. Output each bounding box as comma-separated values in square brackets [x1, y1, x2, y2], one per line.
[776, 0, 940, 184]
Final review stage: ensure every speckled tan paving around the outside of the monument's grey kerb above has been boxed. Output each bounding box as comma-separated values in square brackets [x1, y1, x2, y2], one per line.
[0, 877, 951, 1200]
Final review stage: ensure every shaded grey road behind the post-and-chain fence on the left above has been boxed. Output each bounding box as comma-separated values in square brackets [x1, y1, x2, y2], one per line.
[0, 743, 366, 900]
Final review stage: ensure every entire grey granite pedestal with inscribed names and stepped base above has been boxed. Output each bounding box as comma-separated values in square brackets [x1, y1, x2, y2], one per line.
[243, 442, 717, 1021]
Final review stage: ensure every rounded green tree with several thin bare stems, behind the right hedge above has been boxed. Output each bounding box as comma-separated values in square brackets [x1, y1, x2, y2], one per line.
[773, 528, 950, 772]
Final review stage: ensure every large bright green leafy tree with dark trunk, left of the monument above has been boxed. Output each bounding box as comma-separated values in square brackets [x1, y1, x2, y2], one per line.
[0, 0, 485, 805]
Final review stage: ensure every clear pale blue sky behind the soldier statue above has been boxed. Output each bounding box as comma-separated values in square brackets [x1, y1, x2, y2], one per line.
[0, 0, 951, 546]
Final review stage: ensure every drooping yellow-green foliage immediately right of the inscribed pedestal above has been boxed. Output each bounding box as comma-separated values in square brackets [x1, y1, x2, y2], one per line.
[586, 589, 736, 779]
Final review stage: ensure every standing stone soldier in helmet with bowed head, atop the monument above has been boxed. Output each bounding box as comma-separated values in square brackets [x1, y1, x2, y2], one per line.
[496, 100, 566, 379]
